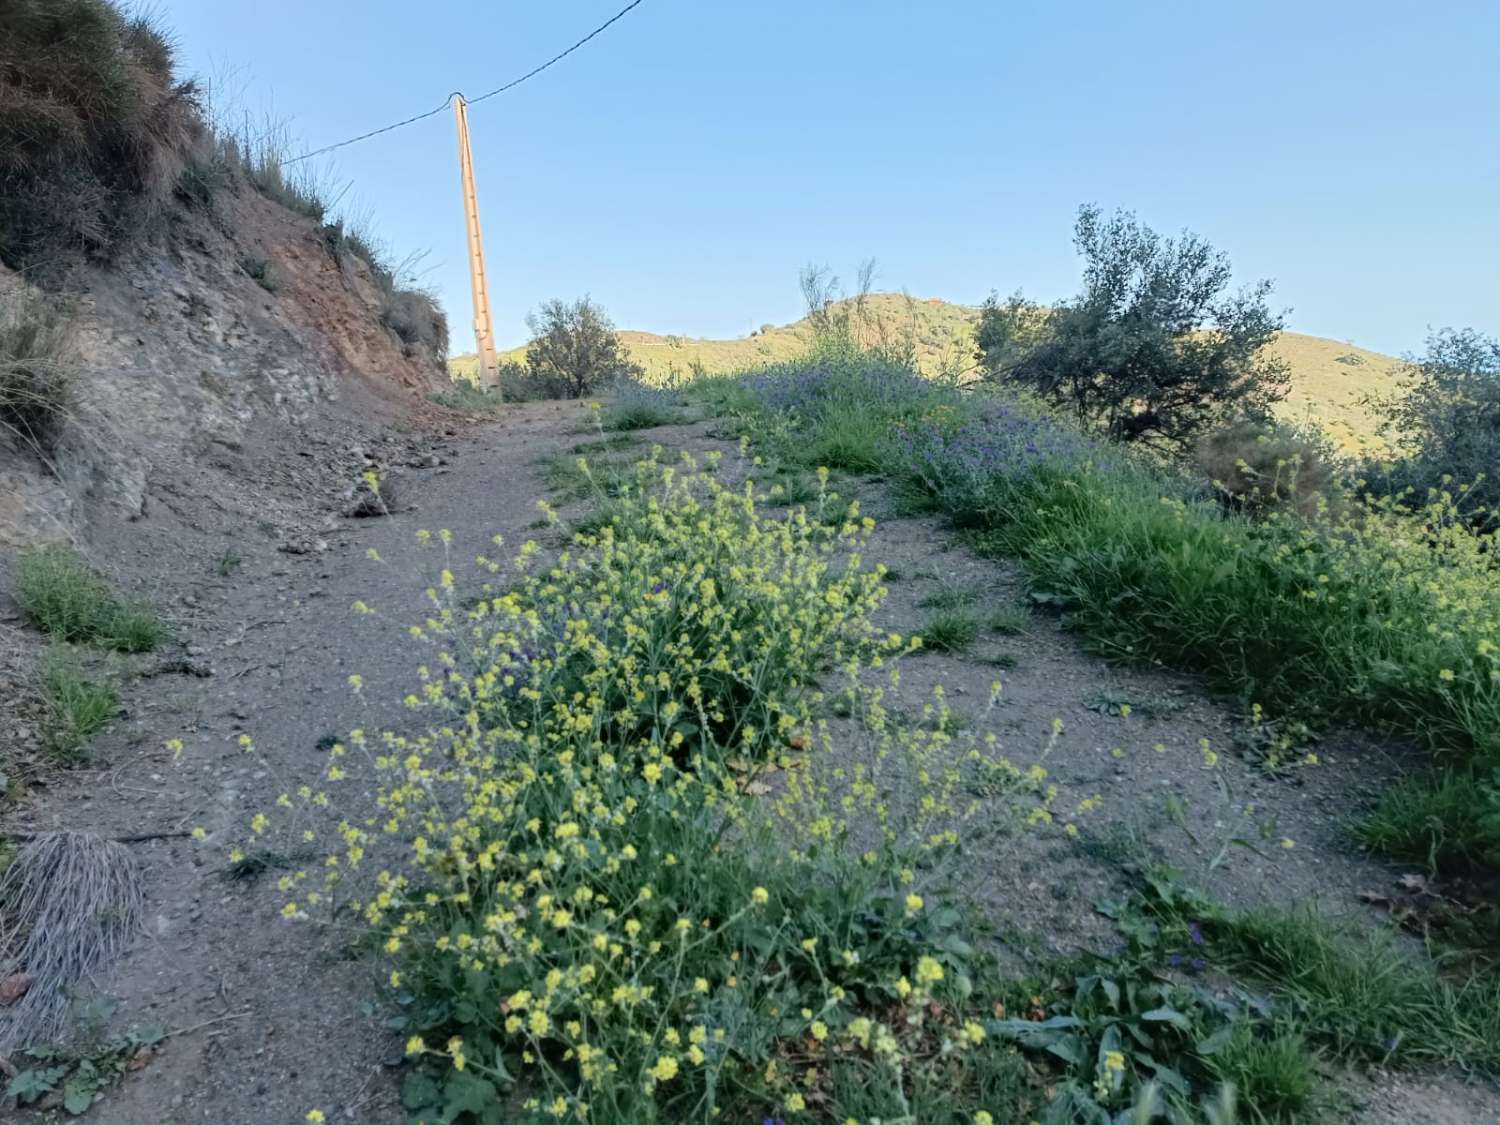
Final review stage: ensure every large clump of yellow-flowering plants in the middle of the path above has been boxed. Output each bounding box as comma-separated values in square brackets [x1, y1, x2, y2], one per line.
[252, 459, 1046, 1124]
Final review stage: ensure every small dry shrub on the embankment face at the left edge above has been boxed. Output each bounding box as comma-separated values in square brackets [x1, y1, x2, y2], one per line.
[0, 294, 77, 456]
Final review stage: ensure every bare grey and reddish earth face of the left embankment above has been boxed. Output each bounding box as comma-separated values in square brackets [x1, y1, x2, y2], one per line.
[0, 185, 447, 548]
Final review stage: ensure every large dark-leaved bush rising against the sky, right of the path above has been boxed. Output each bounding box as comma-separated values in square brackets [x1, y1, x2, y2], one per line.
[977, 206, 1287, 453]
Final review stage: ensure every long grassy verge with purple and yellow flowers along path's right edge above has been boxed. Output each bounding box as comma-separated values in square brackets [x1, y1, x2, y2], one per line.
[702, 345, 1500, 855]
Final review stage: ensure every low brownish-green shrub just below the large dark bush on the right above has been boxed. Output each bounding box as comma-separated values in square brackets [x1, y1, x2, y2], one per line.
[1193, 422, 1338, 518]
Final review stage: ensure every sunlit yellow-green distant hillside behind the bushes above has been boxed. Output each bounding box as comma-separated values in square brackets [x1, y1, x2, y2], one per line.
[449, 293, 1401, 452]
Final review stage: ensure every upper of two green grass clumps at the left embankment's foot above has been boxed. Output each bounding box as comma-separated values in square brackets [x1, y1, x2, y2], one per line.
[11, 545, 167, 653]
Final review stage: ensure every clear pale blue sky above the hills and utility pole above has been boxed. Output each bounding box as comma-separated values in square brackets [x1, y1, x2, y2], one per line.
[156, 0, 1500, 353]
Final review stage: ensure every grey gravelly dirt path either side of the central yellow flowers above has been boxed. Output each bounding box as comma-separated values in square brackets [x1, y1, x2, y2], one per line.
[5, 404, 1500, 1125]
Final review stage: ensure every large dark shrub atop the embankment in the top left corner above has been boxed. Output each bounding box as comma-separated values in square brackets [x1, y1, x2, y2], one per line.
[0, 0, 203, 269]
